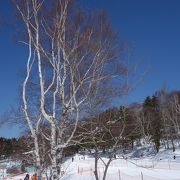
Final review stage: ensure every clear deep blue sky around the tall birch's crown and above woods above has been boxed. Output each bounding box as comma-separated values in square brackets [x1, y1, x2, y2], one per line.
[0, 0, 180, 137]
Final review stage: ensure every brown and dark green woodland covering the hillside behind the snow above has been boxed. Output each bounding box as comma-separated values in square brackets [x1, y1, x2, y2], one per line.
[0, 90, 180, 158]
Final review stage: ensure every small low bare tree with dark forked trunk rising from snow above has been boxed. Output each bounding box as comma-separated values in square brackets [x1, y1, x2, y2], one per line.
[75, 108, 125, 180]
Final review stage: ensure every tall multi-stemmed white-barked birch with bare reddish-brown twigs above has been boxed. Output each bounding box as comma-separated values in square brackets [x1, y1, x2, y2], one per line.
[15, 0, 124, 179]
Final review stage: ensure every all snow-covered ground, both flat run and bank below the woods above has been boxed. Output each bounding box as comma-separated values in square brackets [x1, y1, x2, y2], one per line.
[0, 149, 180, 180]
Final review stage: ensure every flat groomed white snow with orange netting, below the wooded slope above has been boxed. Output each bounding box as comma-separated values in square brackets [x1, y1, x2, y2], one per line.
[60, 155, 180, 180]
